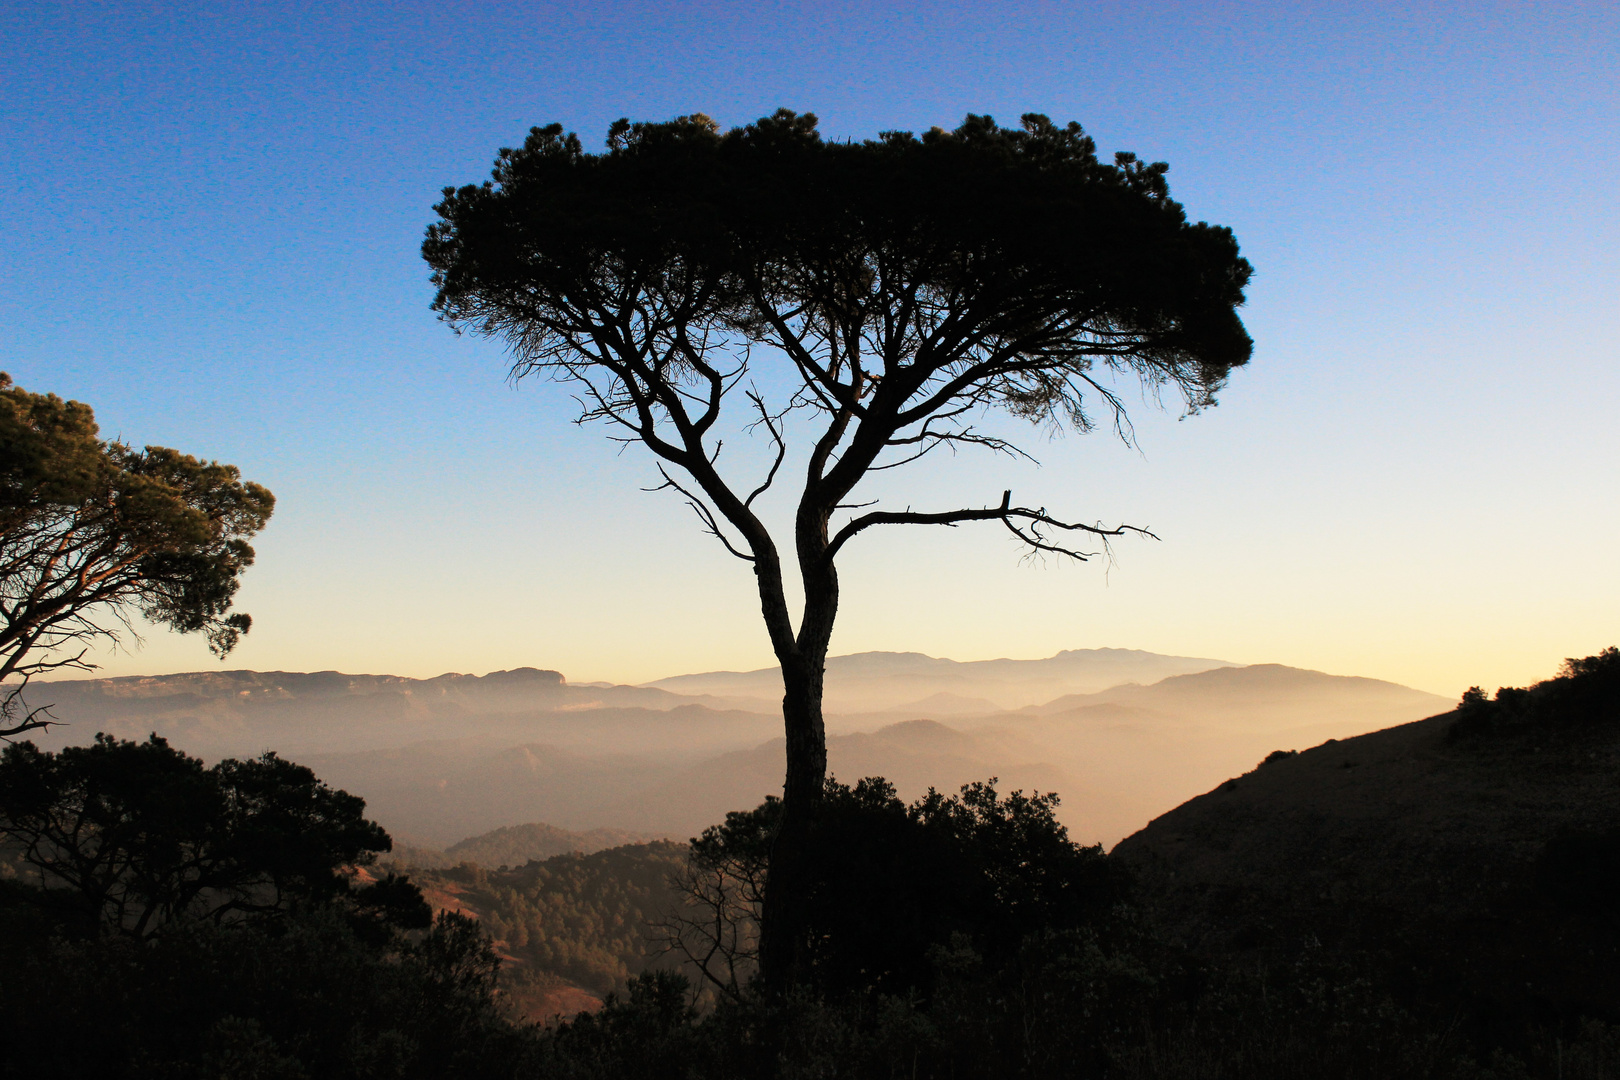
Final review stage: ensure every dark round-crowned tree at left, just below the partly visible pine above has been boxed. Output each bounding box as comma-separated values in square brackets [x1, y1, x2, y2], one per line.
[0, 735, 428, 938]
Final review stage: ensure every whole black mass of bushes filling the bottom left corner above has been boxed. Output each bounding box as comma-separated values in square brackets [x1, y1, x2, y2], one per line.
[0, 735, 522, 1080]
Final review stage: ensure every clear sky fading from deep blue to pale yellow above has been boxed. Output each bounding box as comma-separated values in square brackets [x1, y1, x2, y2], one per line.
[0, 2, 1620, 695]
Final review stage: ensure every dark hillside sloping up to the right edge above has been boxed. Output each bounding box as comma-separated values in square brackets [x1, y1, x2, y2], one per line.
[1115, 660, 1620, 1023]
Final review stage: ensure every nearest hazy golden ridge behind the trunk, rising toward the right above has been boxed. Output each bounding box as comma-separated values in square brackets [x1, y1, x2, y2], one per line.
[612, 664, 1453, 844]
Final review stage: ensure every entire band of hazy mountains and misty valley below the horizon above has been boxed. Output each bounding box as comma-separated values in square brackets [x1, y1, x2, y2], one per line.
[29, 649, 1452, 847]
